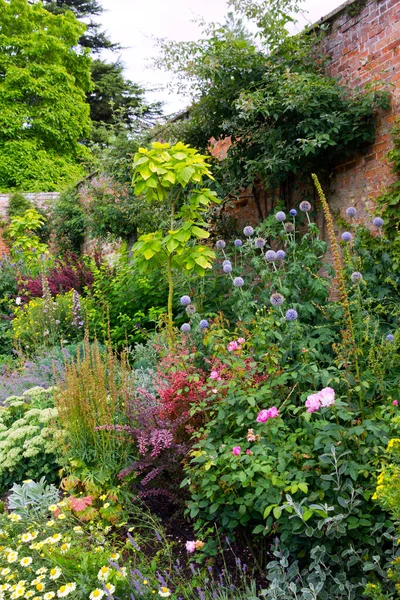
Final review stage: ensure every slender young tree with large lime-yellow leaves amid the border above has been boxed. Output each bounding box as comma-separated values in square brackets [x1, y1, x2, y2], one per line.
[133, 142, 219, 333]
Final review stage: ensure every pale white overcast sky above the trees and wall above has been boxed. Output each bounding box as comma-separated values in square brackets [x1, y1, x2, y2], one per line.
[102, 0, 343, 114]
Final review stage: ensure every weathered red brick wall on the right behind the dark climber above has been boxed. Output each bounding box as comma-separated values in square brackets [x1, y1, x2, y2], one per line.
[227, 0, 400, 224]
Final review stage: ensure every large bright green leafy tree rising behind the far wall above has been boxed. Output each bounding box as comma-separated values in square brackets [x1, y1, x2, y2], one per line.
[0, 0, 91, 191]
